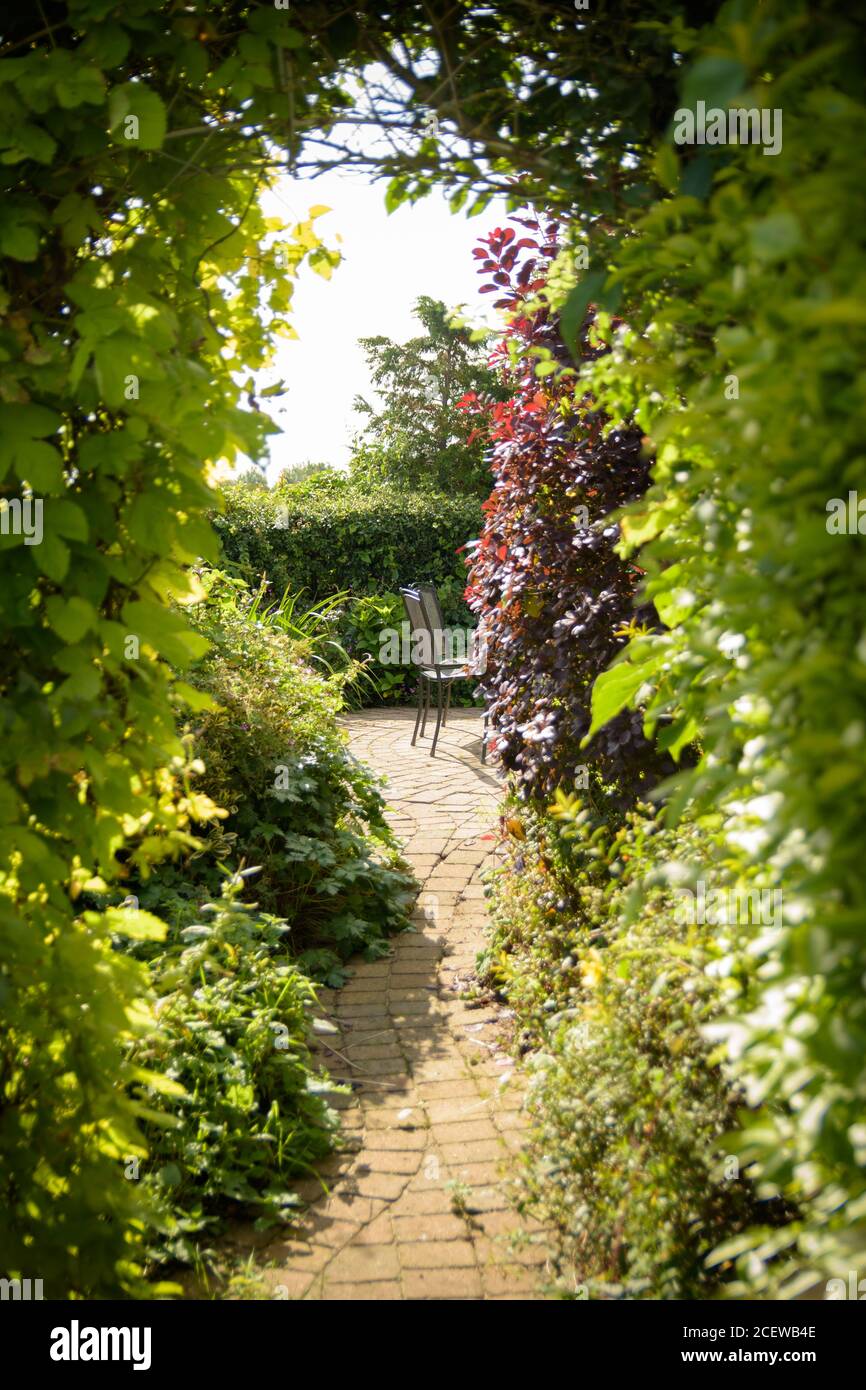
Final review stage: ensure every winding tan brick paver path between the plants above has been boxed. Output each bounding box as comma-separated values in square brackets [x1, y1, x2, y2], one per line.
[258, 709, 556, 1300]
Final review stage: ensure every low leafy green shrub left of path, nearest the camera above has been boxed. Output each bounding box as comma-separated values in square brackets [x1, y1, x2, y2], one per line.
[131, 877, 336, 1259]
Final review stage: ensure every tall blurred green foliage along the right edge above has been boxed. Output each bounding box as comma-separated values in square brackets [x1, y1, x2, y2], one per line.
[558, 3, 866, 1297]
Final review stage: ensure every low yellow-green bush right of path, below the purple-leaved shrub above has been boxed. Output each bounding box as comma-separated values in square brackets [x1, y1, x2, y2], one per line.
[484, 788, 761, 1298]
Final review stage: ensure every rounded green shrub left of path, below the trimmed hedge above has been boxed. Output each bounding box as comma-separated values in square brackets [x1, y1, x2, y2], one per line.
[163, 571, 411, 983]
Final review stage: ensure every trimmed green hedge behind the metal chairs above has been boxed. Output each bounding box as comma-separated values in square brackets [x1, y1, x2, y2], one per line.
[214, 474, 482, 621]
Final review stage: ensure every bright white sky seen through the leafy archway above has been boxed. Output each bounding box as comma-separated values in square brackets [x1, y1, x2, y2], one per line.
[254, 171, 507, 481]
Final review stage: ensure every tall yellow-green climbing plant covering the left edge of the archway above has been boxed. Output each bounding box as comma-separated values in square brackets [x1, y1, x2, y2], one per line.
[0, 0, 336, 1297]
